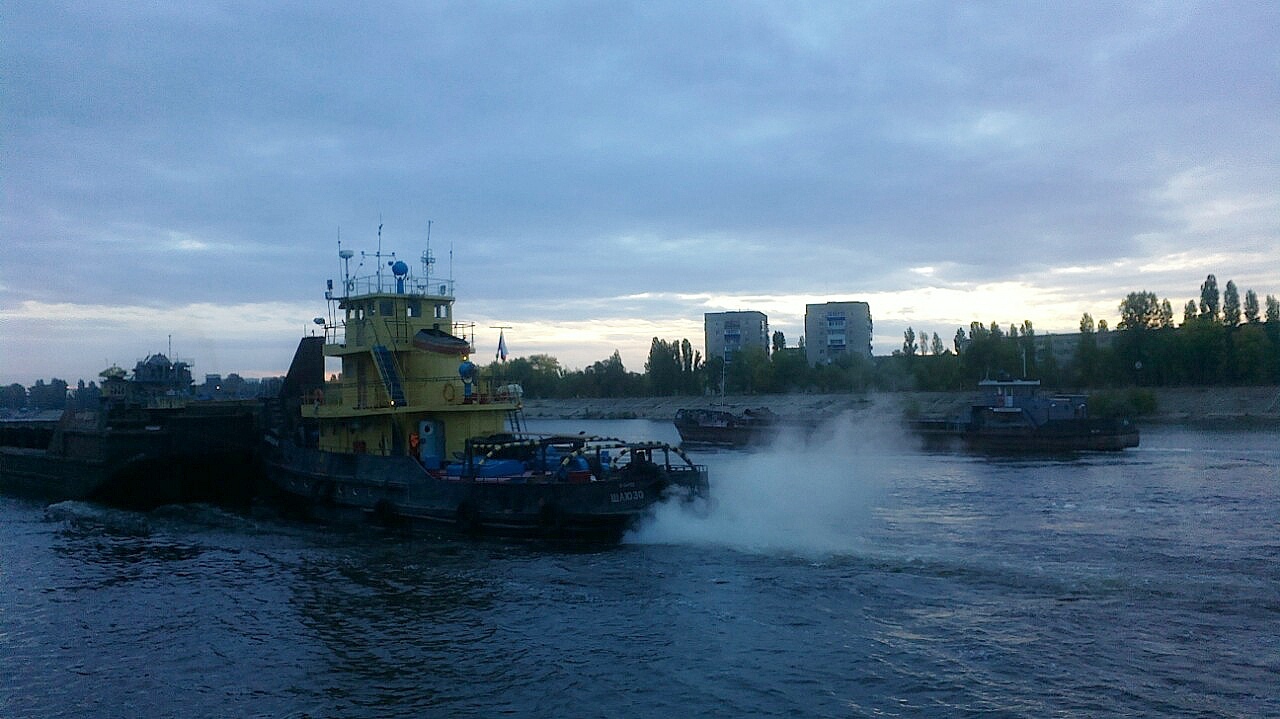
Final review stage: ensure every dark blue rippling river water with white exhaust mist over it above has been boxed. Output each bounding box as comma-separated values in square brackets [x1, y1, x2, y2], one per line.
[0, 421, 1280, 718]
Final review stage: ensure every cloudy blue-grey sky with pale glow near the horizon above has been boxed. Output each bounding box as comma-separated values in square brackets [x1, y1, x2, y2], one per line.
[0, 0, 1280, 384]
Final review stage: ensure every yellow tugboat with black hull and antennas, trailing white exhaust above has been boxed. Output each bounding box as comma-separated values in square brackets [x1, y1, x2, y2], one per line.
[265, 235, 708, 540]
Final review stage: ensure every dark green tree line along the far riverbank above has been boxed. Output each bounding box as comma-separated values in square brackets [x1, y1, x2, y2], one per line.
[10, 275, 1280, 409]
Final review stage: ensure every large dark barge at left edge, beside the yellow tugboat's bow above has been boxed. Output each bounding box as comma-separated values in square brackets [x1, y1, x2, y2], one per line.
[0, 354, 261, 509]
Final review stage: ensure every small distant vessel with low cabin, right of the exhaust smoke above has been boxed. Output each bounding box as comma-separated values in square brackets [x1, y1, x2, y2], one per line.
[909, 380, 1139, 453]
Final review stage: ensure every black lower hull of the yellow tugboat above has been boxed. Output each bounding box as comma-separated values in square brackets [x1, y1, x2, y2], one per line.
[265, 445, 678, 541]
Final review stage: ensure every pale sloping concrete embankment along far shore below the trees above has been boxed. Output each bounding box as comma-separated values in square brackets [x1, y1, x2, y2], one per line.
[525, 386, 1280, 430]
